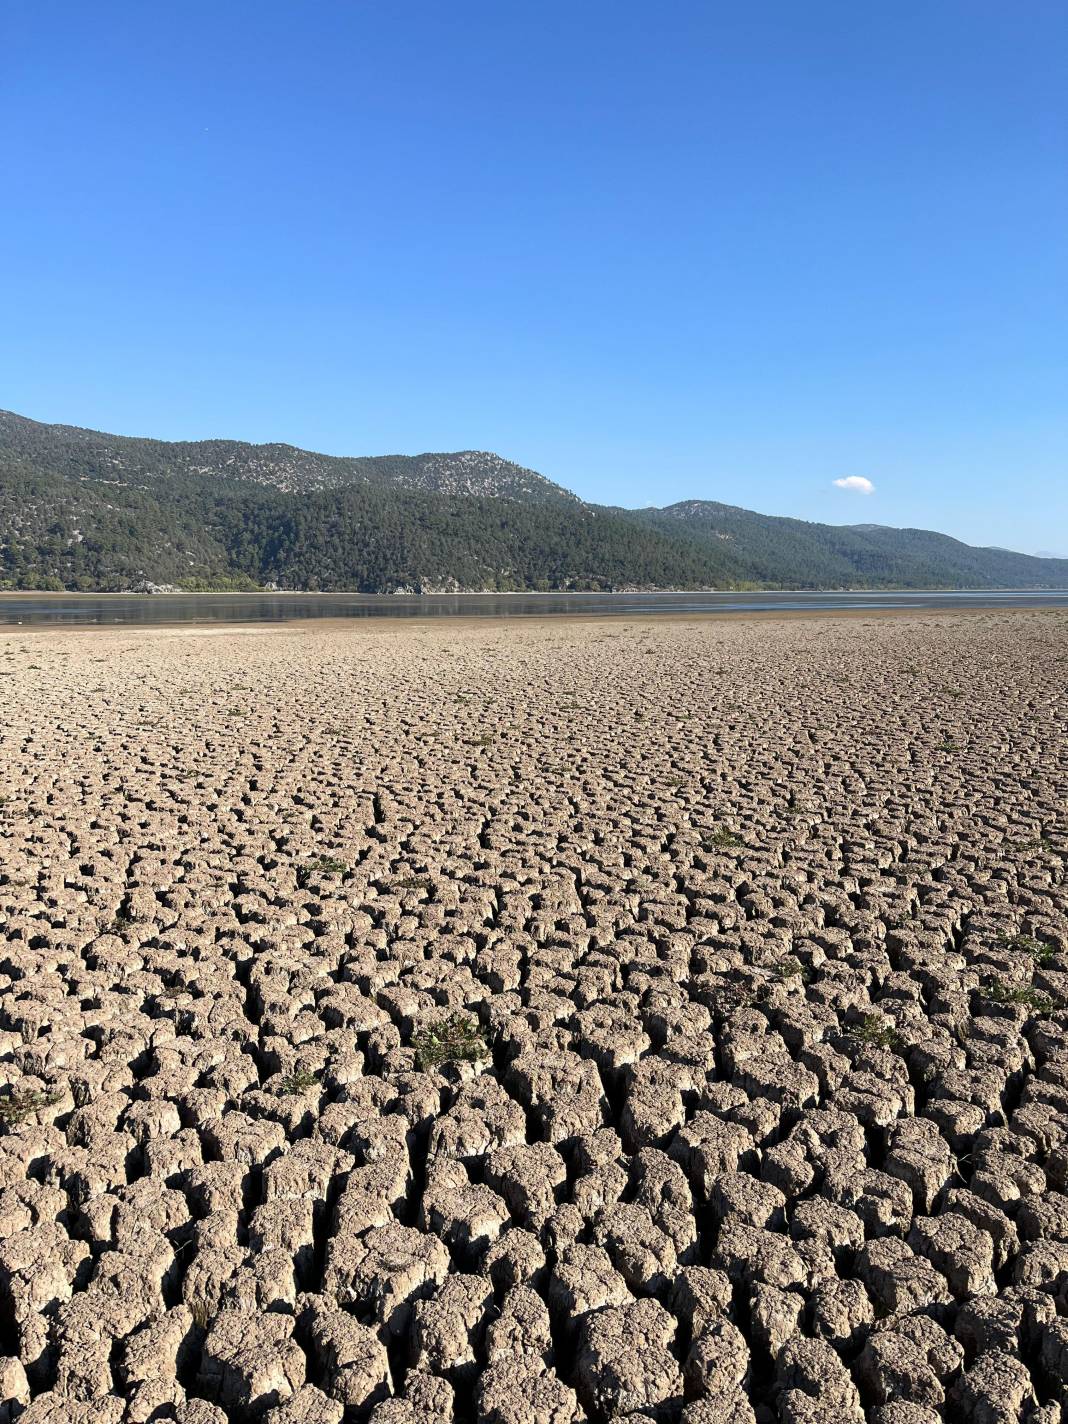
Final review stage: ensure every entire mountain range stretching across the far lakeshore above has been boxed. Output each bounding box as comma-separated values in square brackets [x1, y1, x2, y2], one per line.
[0, 412, 1068, 592]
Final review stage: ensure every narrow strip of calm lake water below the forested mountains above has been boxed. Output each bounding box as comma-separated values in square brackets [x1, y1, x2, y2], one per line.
[0, 590, 1068, 625]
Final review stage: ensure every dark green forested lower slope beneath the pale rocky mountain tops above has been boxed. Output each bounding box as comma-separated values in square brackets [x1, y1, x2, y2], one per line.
[0, 450, 736, 592]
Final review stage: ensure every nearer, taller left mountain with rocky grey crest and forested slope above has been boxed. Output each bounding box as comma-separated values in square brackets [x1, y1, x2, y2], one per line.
[0, 413, 722, 592]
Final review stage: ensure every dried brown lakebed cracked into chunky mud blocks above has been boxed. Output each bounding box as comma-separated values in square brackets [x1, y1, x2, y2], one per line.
[0, 611, 1068, 1424]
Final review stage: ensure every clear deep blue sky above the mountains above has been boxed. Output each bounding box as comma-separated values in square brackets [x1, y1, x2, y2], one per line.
[0, 0, 1068, 554]
